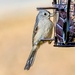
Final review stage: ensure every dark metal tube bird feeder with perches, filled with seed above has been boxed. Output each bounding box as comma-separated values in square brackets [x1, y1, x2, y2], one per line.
[37, 0, 75, 47]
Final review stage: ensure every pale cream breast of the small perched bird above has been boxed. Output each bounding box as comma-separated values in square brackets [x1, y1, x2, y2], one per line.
[39, 20, 53, 36]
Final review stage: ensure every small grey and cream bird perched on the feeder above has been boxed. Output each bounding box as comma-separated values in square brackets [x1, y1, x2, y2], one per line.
[24, 9, 53, 70]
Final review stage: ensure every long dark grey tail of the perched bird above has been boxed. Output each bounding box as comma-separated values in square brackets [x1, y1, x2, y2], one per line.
[24, 45, 37, 70]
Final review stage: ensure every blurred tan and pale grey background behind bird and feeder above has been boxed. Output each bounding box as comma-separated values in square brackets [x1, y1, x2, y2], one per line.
[0, 0, 75, 75]
